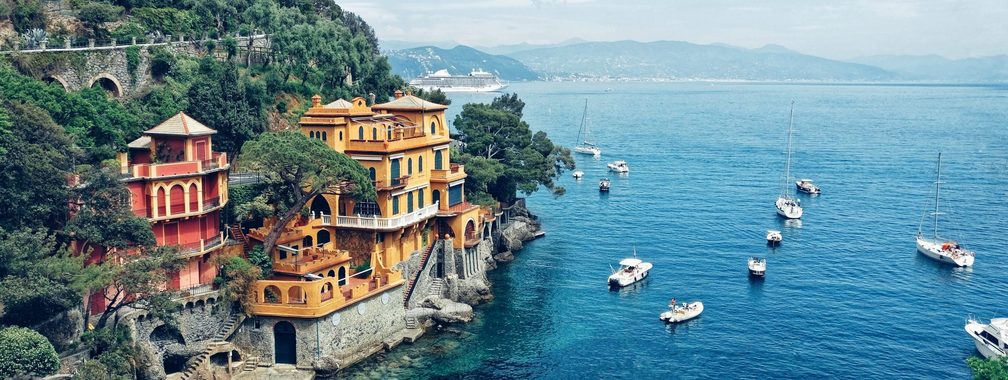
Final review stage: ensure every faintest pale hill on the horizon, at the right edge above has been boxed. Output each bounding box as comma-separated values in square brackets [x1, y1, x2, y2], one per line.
[852, 55, 1008, 83]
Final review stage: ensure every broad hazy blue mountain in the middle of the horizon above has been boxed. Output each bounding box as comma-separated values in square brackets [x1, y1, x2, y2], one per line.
[511, 41, 894, 82]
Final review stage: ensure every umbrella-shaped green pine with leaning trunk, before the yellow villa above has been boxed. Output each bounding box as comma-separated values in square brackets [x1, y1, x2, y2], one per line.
[239, 131, 375, 252]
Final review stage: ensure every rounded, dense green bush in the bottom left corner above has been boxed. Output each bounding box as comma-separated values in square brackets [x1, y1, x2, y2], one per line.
[0, 327, 59, 379]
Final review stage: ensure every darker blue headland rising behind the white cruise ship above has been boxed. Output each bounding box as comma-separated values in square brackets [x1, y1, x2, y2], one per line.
[387, 45, 539, 81]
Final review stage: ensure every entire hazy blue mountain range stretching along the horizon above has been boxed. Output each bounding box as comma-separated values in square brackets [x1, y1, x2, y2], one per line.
[382, 39, 1008, 83]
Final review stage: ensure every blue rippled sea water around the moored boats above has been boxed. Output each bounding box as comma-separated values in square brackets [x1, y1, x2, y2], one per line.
[343, 83, 1008, 379]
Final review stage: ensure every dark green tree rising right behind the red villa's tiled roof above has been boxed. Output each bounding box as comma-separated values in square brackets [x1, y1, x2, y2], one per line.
[186, 57, 266, 157]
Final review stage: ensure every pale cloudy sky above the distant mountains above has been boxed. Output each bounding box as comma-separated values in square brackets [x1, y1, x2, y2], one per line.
[338, 0, 1008, 59]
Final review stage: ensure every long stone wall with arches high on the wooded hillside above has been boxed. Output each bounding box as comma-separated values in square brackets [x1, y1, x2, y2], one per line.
[0, 34, 268, 98]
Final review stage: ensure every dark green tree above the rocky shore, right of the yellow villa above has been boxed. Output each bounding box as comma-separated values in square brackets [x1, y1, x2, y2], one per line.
[455, 94, 575, 201]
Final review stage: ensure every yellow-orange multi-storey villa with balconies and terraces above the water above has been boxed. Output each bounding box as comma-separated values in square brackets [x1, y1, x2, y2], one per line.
[248, 92, 493, 318]
